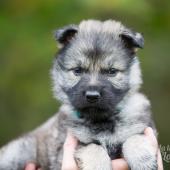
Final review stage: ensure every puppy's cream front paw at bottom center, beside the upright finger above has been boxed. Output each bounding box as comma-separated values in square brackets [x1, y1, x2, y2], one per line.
[75, 144, 112, 170]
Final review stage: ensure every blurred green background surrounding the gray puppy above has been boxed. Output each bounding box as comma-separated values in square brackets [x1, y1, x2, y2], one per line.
[0, 0, 170, 169]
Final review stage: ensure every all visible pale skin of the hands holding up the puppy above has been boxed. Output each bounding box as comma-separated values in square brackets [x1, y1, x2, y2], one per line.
[25, 127, 163, 170]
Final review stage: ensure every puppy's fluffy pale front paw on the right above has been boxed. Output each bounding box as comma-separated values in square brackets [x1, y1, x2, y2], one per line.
[122, 135, 158, 170]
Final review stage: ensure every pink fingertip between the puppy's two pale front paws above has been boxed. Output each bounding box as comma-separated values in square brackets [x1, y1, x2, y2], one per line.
[112, 159, 128, 170]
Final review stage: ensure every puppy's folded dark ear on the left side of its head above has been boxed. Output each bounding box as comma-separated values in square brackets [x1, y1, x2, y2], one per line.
[54, 25, 78, 46]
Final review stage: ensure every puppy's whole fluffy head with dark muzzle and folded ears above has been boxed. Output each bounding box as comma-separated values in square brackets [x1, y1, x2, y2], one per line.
[52, 21, 143, 119]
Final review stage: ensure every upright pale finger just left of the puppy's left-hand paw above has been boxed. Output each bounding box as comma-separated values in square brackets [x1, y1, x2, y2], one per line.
[62, 133, 78, 170]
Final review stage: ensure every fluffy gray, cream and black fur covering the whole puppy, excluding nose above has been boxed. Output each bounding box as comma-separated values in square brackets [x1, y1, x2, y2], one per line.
[0, 20, 157, 170]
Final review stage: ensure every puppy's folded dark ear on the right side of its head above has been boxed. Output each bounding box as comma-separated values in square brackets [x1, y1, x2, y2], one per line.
[120, 30, 144, 52]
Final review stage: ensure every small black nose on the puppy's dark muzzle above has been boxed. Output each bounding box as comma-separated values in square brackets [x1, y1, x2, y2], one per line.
[85, 90, 100, 103]
